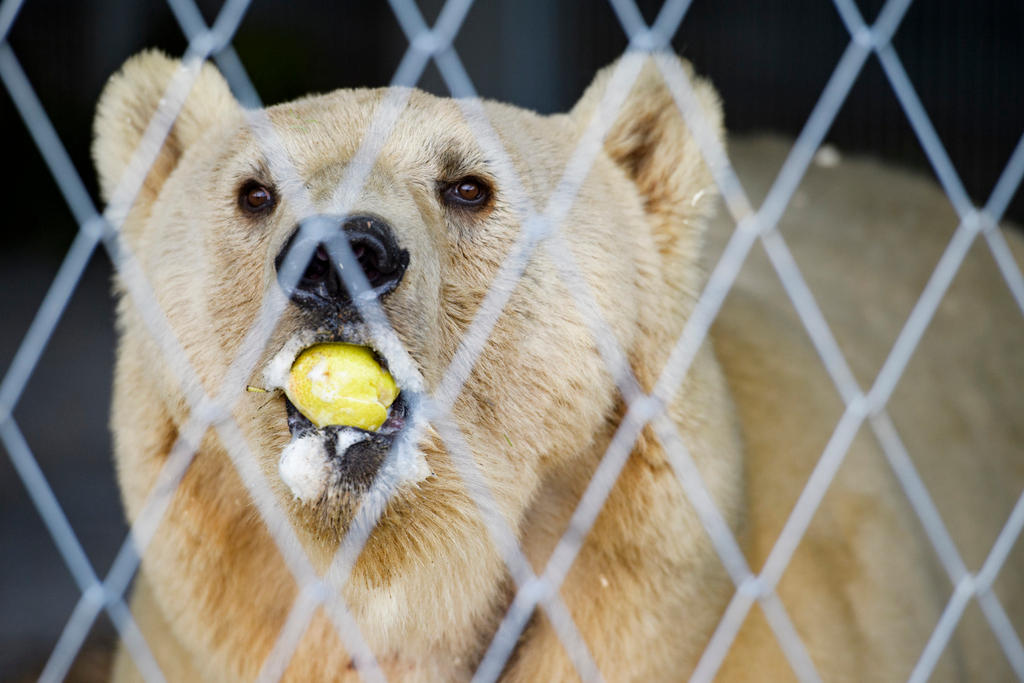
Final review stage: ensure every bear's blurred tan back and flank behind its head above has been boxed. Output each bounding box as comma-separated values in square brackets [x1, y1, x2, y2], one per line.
[708, 139, 1024, 680]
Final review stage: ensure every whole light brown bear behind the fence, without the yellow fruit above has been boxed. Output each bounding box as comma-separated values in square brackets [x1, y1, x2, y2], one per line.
[94, 52, 1024, 681]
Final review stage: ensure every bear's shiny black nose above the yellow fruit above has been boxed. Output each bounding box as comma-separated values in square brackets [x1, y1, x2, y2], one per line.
[274, 216, 409, 307]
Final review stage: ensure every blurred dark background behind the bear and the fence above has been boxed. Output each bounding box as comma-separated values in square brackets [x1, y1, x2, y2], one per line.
[0, 0, 1024, 679]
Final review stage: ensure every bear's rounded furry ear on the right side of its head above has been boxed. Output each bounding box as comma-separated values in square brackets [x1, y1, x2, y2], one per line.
[569, 53, 722, 268]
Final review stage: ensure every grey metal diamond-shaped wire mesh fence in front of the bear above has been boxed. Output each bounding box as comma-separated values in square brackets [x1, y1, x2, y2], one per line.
[0, 0, 1024, 680]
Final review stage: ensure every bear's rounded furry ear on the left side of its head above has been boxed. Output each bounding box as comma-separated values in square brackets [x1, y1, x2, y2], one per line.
[92, 50, 241, 203]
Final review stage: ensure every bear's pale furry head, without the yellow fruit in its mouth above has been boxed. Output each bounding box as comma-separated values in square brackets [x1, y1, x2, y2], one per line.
[94, 52, 721, 565]
